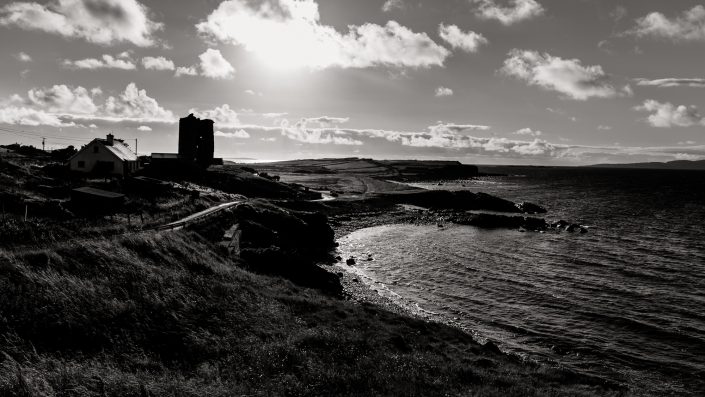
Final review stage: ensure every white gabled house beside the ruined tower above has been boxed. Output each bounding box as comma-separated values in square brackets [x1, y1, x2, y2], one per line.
[68, 134, 139, 176]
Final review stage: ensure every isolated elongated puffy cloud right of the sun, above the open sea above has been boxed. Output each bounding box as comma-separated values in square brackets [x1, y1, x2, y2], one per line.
[501, 49, 631, 101]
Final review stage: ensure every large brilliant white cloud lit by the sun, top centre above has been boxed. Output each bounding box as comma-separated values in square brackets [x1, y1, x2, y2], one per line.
[196, 0, 450, 69]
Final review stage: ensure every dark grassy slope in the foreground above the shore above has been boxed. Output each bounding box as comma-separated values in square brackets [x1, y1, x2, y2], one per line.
[0, 231, 617, 396]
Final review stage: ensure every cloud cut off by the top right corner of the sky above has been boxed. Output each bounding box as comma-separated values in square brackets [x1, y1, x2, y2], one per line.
[626, 5, 705, 41]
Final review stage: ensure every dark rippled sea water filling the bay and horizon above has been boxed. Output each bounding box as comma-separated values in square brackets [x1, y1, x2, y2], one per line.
[339, 167, 705, 395]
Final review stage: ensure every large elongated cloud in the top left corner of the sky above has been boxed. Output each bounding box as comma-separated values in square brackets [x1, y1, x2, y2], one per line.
[0, 0, 162, 47]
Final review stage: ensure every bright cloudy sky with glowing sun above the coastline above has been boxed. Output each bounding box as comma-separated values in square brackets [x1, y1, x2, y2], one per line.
[0, 0, 705, 165]
